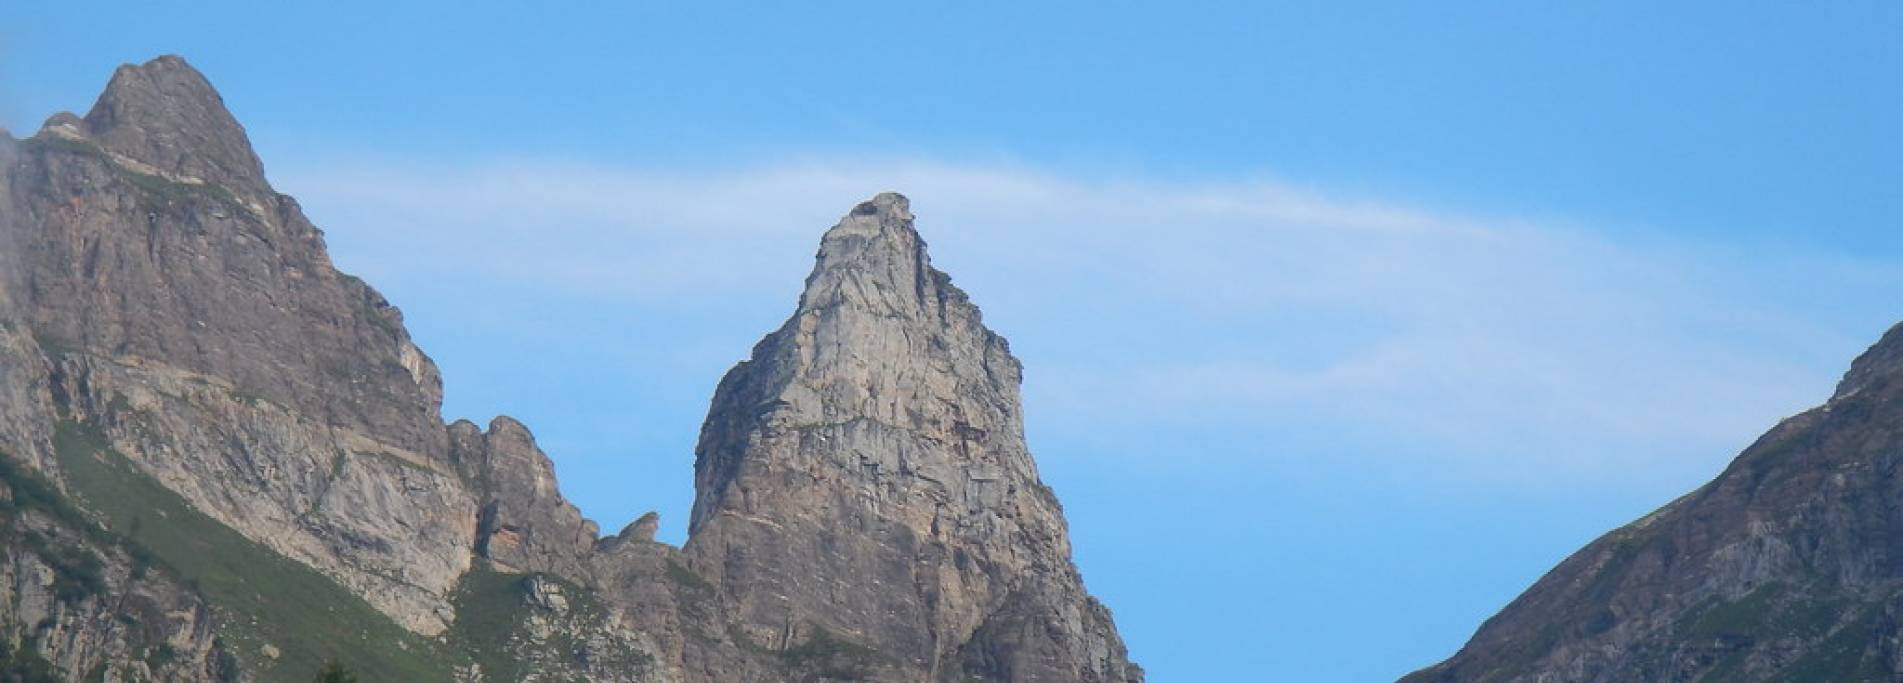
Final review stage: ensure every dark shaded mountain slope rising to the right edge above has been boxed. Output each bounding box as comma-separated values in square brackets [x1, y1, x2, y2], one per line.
[1404, 325, 1903, 683]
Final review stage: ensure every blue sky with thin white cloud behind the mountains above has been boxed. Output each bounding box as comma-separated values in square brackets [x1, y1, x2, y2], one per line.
[0, 2, 1903, 683]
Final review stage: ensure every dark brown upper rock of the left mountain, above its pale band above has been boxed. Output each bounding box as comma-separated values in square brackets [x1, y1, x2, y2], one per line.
[13, 55, 443, 455]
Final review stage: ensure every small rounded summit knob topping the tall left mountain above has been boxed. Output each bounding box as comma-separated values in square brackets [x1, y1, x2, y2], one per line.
[46, 55, 265, 190]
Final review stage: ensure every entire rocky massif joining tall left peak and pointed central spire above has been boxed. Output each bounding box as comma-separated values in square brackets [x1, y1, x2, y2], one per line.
[0, 57, 1142, 683]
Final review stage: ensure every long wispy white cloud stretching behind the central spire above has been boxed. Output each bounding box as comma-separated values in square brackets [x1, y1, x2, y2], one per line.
[276, 160, 1903, 479]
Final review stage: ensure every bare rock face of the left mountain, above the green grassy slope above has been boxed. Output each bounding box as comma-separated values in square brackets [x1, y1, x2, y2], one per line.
[0, 57, 476, 632]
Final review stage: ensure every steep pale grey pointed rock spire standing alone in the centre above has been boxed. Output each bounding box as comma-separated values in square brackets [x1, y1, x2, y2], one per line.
[685, 194, 1142, 681]
